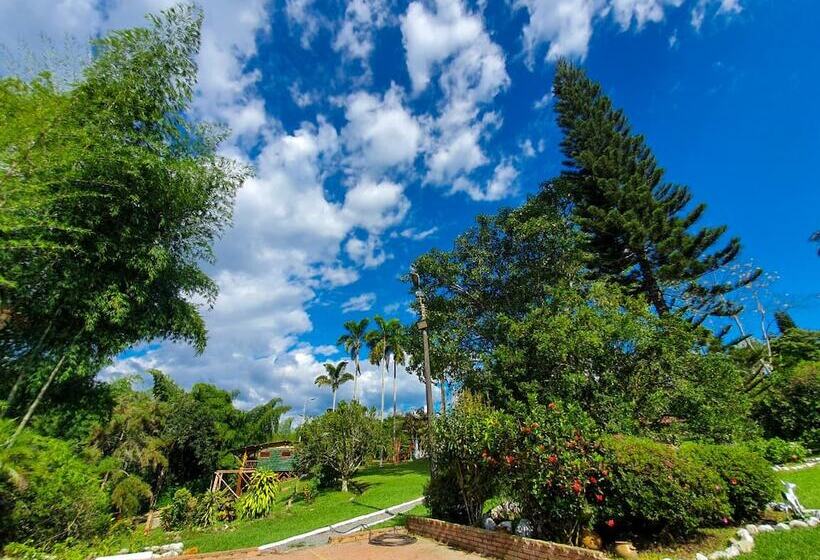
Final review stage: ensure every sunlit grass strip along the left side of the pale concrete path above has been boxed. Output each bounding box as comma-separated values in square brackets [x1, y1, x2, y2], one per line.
[150, 461, 429, 552]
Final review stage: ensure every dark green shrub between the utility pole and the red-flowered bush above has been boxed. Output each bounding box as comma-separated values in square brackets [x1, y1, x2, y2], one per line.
[424, 393, 513, 524]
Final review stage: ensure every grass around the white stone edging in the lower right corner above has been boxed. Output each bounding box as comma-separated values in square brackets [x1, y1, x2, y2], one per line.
[639, 467, 820, 560]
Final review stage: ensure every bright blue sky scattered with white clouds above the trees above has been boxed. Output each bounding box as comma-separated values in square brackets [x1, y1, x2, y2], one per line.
[0, 0, 820, 418]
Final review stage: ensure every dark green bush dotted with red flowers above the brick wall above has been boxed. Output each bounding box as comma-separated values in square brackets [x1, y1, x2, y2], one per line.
[499, 403, 607, 543]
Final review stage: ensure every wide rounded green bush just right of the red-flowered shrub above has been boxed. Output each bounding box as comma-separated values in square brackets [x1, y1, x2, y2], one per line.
[597, 436, 731, 540]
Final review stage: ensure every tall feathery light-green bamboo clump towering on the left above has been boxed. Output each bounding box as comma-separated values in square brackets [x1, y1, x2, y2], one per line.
[0, 6, 249, 439]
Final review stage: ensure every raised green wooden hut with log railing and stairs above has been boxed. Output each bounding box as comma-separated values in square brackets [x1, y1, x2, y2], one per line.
[211, 441, 295, 498]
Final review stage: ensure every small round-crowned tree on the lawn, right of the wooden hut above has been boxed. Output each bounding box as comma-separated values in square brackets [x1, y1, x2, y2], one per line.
[297, 402, 381, 492]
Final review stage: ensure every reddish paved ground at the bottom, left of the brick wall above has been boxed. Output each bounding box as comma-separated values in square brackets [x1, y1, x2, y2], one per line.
[187, 537, 482, 560]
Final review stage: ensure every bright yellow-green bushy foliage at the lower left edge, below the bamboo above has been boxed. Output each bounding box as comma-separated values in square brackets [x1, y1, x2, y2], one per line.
[0, 420, 112, 546]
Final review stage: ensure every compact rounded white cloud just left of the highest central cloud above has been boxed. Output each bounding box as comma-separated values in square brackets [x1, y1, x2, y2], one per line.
[342, 84, 422, 173]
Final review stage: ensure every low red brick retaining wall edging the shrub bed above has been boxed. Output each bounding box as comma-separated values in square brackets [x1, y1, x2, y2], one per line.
[407, 516, 607, 560]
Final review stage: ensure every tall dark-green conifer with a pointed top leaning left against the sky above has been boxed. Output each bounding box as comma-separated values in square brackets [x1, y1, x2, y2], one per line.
[553, 61, 759, 322]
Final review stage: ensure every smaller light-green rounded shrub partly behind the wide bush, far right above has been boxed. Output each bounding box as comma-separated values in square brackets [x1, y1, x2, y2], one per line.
[681, 443, 778, 523]
